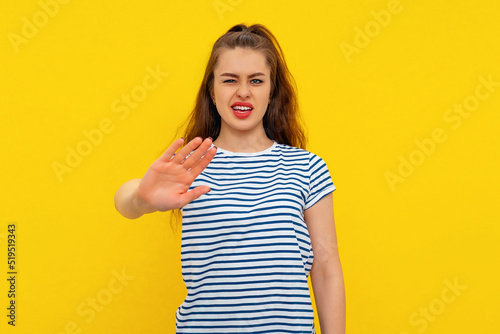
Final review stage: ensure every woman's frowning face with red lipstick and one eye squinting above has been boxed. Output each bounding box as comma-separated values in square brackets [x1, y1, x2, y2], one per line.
[212, 47, 271, 136]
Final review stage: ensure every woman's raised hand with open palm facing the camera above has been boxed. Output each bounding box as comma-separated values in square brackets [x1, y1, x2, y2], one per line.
[134, 137, 217, 213]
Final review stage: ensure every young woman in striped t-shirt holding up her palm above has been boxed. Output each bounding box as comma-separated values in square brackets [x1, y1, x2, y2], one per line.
[115, 24, 345, 334]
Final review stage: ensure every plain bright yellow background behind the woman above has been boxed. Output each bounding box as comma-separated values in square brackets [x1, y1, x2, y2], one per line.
[0, 0, 500, 334]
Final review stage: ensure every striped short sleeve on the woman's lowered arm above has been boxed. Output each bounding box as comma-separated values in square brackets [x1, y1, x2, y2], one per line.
[304, 153, 336, 209]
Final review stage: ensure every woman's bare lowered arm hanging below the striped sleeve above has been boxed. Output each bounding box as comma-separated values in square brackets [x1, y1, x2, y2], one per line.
[304, 193, 346, 334]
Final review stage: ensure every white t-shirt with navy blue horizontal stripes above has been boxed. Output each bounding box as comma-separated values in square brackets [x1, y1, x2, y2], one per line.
[176, 142, 335, 334]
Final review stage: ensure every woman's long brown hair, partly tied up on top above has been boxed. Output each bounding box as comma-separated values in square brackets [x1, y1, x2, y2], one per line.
[172, 24, 307, 232]
